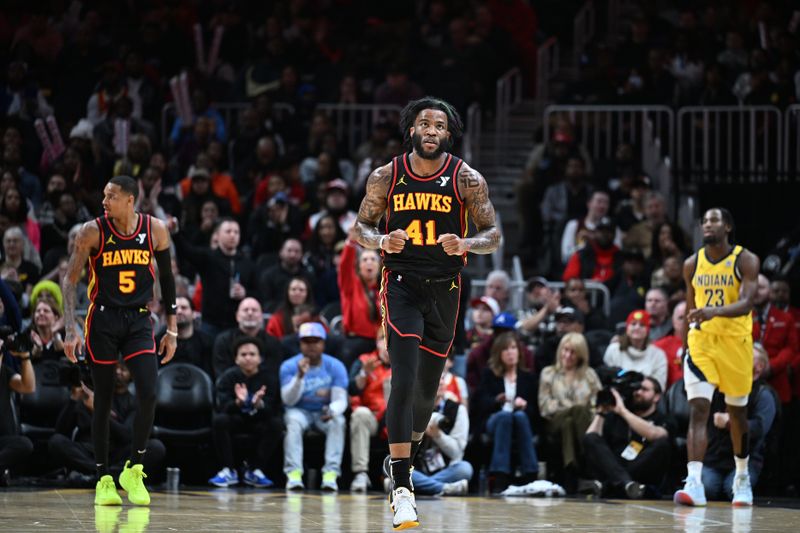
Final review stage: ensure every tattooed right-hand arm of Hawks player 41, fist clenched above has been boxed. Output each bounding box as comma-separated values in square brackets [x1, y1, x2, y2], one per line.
[437, 163, 500, 255]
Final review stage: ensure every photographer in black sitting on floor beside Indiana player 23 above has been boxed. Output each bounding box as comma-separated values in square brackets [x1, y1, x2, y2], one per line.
[583, 372, 671, 500]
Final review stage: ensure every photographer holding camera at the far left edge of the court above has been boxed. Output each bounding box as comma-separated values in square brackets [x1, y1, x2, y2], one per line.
[0, 326, 36, 486]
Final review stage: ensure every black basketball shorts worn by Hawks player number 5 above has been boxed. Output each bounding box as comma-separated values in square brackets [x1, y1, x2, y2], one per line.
[86, 304, 156, 365]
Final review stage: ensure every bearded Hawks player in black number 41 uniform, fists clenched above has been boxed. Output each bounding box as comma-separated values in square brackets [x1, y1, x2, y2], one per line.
[355, 97, 500, 530]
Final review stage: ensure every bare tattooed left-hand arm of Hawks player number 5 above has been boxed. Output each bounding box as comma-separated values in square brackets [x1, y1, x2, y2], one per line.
[61, 220, 100, 363]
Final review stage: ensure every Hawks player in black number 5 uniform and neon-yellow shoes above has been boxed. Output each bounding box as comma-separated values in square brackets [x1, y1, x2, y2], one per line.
[62, 176, 178, 505]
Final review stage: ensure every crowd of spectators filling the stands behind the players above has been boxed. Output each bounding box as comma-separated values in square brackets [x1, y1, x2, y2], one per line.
[0, 0, 800, 498]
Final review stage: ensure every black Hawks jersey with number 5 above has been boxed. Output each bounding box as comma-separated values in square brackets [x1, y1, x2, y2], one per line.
[89, 214, 155, 308]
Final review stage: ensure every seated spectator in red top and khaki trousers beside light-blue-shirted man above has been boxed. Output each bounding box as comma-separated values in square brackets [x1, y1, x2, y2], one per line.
[348, 327, 392, 492]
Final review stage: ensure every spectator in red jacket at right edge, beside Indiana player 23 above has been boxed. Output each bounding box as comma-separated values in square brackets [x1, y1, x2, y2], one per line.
[753, 274, 799, 405]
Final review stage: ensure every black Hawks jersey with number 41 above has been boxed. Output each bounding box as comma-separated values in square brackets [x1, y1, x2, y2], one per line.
[383, 150, 467, 279]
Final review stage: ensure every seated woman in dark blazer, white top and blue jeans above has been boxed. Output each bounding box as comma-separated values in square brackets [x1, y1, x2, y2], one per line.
[475, 332, 539, 492]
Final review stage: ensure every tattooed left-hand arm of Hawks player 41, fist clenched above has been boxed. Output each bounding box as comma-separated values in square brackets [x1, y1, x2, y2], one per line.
[353, 163, 408, 254]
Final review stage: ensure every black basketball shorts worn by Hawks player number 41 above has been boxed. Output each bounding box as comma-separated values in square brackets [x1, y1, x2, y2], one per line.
[381, 268, 461, 357]
